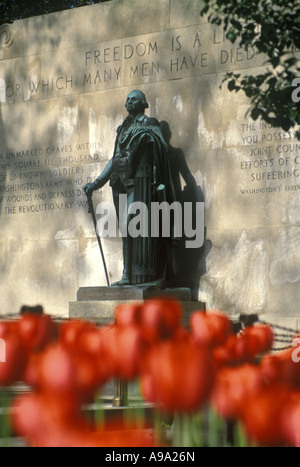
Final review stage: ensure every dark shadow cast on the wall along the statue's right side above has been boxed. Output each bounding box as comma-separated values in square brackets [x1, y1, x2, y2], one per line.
[160, 121, 211, 301]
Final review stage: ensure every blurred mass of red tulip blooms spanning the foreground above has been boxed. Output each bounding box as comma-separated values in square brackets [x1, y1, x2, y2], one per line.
[0, 298, 300, 447]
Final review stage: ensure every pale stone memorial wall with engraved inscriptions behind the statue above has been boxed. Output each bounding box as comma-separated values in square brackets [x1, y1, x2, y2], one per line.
[0, 0, 300, 326]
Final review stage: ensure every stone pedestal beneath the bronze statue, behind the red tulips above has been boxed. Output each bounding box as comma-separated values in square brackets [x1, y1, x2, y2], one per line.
[69, 286, 205, 326]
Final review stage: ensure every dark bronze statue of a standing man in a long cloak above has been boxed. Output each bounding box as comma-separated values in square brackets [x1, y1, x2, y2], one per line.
[83, 90, 175, 286]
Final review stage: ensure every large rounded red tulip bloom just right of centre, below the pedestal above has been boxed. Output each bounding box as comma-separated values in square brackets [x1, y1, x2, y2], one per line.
[141, 339, 213, 412]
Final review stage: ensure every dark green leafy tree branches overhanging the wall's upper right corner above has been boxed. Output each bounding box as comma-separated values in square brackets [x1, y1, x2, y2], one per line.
[200, 0, 300, 135]
